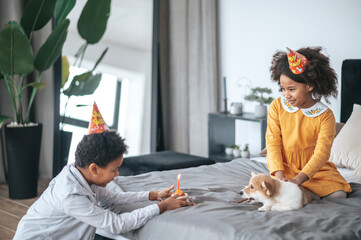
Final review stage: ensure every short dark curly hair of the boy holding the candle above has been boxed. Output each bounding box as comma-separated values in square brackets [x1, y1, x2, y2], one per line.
[75, 130, 128, 168]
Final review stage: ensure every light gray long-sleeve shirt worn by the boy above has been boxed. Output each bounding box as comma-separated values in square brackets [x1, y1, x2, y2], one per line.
[14, 164, 159, 240]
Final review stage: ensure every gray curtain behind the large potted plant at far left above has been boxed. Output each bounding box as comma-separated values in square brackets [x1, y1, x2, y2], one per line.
[0, 0, 54, 182]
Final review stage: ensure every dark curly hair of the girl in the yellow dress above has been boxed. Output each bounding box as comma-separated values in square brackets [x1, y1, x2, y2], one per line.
[270, 47, 338, 103]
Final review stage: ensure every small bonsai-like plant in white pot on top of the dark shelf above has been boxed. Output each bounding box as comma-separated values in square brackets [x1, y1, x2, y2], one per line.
[244, 87, 273, 118]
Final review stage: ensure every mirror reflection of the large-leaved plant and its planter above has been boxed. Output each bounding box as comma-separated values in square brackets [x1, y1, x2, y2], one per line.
[53, 0, 111, 176]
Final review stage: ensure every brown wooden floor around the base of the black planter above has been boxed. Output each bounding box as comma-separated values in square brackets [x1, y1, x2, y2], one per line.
[0, 179, 50, 240]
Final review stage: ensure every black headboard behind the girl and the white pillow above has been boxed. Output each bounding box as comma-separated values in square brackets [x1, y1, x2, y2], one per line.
[341, 59, 361, 123]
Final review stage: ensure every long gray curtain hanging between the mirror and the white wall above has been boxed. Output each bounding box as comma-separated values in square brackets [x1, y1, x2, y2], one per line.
[159, 0, 220, 157]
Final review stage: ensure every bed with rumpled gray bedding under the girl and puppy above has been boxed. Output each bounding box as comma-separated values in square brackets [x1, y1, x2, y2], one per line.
[100, 60, 361, 240]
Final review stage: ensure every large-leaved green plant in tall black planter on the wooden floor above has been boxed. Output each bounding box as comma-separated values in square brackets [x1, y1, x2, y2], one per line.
[0, 0, 71, 199]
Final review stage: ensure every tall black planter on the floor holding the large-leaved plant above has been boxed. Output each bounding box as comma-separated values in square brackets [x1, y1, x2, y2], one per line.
[5, 124, 43, 199]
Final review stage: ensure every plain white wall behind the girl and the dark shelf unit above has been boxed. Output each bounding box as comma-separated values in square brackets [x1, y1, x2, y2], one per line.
[218, 0, 361, 153]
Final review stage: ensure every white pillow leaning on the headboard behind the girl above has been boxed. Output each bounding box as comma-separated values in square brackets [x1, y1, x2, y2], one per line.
[330, 104, 361, 177]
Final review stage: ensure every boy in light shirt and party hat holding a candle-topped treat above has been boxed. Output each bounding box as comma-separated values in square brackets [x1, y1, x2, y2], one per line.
[14, 104, 191, 239]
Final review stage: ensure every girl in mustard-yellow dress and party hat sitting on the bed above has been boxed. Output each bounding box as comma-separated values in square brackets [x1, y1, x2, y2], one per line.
[266, 47, 352, 198]
